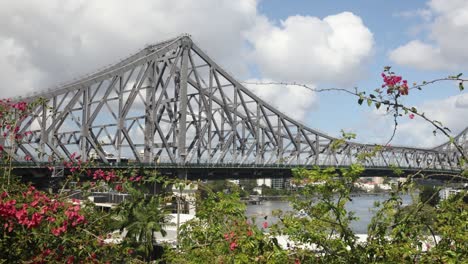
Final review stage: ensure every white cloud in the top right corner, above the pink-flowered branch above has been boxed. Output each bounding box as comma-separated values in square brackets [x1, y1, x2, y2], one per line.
[390, 0, 468, 70]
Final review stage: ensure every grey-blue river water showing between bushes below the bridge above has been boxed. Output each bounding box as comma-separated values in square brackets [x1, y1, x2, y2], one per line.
[246, 193, 412, 234]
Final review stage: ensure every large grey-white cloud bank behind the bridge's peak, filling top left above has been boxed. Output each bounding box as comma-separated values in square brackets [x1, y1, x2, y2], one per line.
[0, 0, 257, 97]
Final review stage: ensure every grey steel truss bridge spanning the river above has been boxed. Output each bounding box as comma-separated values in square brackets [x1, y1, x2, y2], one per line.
[0, 35, 468, 176]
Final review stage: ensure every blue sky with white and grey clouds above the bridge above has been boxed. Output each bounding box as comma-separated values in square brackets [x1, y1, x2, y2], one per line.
[0, 0, 468, 148]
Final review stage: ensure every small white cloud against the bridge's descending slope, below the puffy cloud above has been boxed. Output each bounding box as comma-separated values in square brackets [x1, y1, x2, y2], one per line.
[246, 79, 318, 121]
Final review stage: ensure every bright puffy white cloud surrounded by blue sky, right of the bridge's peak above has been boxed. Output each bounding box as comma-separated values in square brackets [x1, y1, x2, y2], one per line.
[247, 12, 374, 83]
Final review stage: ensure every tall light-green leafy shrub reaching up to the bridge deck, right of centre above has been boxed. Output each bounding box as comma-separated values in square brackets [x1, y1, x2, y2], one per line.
[272, 165, 363, 263]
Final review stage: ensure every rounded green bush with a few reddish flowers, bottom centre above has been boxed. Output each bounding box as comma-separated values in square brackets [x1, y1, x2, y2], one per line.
[165, 189, 291, 263]
